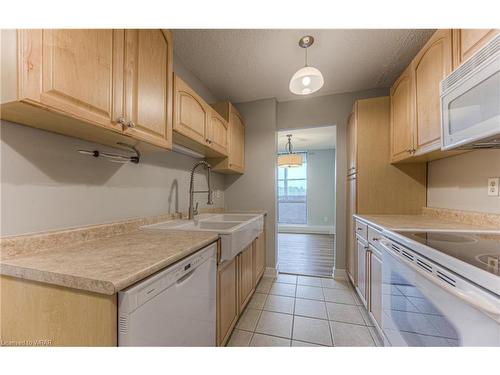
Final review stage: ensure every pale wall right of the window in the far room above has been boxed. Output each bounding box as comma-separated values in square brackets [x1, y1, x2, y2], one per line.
[307, 149, 335, 227]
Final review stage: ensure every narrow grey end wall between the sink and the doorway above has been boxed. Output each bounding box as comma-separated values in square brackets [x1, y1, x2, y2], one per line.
[224, 99, 276, 267]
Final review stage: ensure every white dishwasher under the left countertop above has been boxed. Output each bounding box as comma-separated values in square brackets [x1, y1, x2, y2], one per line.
[118, 243, 217, 346]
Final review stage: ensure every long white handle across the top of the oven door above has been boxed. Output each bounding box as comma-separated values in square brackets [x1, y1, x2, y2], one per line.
[379, 241, 500, 323]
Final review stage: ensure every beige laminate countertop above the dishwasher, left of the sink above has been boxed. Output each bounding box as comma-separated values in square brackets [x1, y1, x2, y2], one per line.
[0, 229, 219, 295]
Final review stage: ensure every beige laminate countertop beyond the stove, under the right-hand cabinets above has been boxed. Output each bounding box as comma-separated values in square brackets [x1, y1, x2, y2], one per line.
[354, 215, 500, 232]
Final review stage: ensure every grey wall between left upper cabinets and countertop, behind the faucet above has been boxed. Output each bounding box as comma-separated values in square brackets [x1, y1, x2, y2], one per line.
[1, 121, 224, 237]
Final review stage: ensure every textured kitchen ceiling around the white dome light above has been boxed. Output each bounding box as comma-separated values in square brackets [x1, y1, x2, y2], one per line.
[173, 29, 433, 103]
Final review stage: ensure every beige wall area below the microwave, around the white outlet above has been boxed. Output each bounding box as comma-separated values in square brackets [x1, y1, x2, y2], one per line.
[427, 150, 500, 214]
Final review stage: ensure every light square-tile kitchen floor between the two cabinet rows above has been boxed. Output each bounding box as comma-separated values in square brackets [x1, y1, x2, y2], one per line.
[228, 274, 379, 346]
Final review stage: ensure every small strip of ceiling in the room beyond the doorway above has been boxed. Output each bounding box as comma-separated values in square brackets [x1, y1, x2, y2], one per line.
[277, 126, 336, 152]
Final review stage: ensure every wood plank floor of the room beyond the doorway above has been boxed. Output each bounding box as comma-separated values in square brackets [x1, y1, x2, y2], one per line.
[278, 233, 334, 277]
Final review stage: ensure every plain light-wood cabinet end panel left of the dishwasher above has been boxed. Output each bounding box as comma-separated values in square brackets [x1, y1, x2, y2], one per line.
[0, 276, 117, 346]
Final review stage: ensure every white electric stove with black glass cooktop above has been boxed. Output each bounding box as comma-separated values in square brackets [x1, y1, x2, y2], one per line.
[380, 231, 500, 346]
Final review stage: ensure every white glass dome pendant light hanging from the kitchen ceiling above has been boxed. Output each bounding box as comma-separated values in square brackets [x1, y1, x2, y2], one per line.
[289, 35, 324, 95]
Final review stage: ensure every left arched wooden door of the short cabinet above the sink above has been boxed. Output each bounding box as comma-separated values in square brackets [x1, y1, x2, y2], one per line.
[174, 76, 211, 145]
